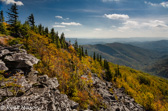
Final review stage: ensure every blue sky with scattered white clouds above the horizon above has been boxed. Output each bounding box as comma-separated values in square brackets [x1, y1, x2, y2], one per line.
[0, 0, 168, 38]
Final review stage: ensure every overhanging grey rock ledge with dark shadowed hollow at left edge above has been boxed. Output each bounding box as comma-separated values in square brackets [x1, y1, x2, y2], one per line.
[0, 45, 39, 76]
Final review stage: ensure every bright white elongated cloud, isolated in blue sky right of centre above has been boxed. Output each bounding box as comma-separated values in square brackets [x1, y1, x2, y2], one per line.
[104, 14, 129, 20]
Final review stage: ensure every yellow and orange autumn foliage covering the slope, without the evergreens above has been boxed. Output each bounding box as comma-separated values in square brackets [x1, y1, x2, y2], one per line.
[17, 32, 168, 111]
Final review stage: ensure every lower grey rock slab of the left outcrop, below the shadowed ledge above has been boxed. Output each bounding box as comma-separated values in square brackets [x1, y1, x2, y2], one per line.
[0, 75, 78, 111]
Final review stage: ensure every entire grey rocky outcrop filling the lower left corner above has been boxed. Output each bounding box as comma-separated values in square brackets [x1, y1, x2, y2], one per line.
[0, 46, 79, 111]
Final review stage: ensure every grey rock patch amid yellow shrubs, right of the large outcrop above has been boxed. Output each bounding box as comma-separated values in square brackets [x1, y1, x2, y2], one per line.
[88, 74, 145, 111]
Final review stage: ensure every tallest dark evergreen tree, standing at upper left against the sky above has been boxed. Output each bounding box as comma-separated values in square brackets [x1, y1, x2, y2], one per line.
[7, 3, 19, 36]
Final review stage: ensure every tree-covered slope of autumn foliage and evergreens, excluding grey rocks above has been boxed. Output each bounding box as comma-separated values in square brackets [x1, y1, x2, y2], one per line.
[0, 4, 168, 111]
